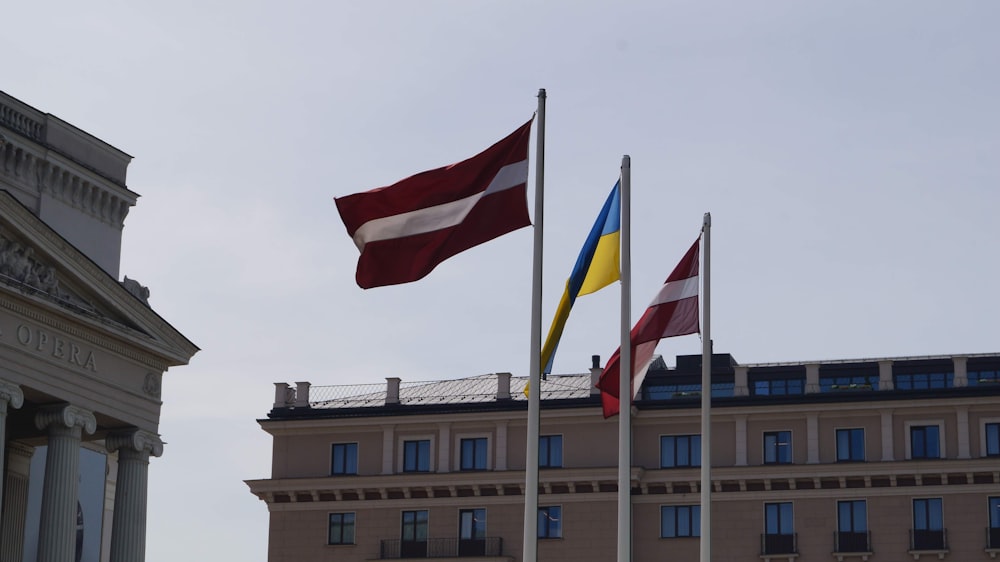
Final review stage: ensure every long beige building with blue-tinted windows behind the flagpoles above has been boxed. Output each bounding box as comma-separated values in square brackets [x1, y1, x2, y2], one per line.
[248, 354, 1000, 562]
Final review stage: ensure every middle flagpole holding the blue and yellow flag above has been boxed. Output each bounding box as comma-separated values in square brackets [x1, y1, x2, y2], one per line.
[618, 154, 632, 562]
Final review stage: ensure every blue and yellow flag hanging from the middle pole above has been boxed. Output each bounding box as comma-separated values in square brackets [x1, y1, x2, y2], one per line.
[541, 182, 621, 374]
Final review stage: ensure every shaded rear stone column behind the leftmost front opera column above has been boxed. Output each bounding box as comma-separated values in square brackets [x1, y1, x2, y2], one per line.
[0, 442, 35, 562]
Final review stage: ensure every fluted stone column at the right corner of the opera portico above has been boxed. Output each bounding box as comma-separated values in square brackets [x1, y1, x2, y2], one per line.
[104, 429, 163, 562]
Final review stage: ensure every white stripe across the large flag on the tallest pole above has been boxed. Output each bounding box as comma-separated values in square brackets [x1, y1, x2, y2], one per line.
[354, 160, 528, 250]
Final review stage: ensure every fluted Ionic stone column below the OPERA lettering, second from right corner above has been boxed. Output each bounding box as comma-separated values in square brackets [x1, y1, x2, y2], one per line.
[35, 404, 97, 562]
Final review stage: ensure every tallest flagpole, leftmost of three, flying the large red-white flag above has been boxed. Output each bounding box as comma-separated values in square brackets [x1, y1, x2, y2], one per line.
[521, 88, 545, 562]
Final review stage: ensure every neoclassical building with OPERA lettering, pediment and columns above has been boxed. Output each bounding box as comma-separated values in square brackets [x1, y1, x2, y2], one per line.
[0, 92, 198, 562]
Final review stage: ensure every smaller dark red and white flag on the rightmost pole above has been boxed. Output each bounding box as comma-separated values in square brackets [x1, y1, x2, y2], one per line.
[597, 238, 701, 418]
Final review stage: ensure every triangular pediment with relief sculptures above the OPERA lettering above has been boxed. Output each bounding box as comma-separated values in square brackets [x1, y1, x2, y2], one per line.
[0, 190, 198, 367]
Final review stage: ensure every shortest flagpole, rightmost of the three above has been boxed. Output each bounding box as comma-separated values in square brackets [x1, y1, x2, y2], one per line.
[700, 213, 712, 562]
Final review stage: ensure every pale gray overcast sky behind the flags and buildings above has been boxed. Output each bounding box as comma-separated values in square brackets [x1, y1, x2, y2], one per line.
[0, 0, 1000, 562]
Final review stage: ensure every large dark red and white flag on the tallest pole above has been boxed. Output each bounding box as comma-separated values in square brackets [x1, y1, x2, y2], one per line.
[335, 117, 532, 289]
